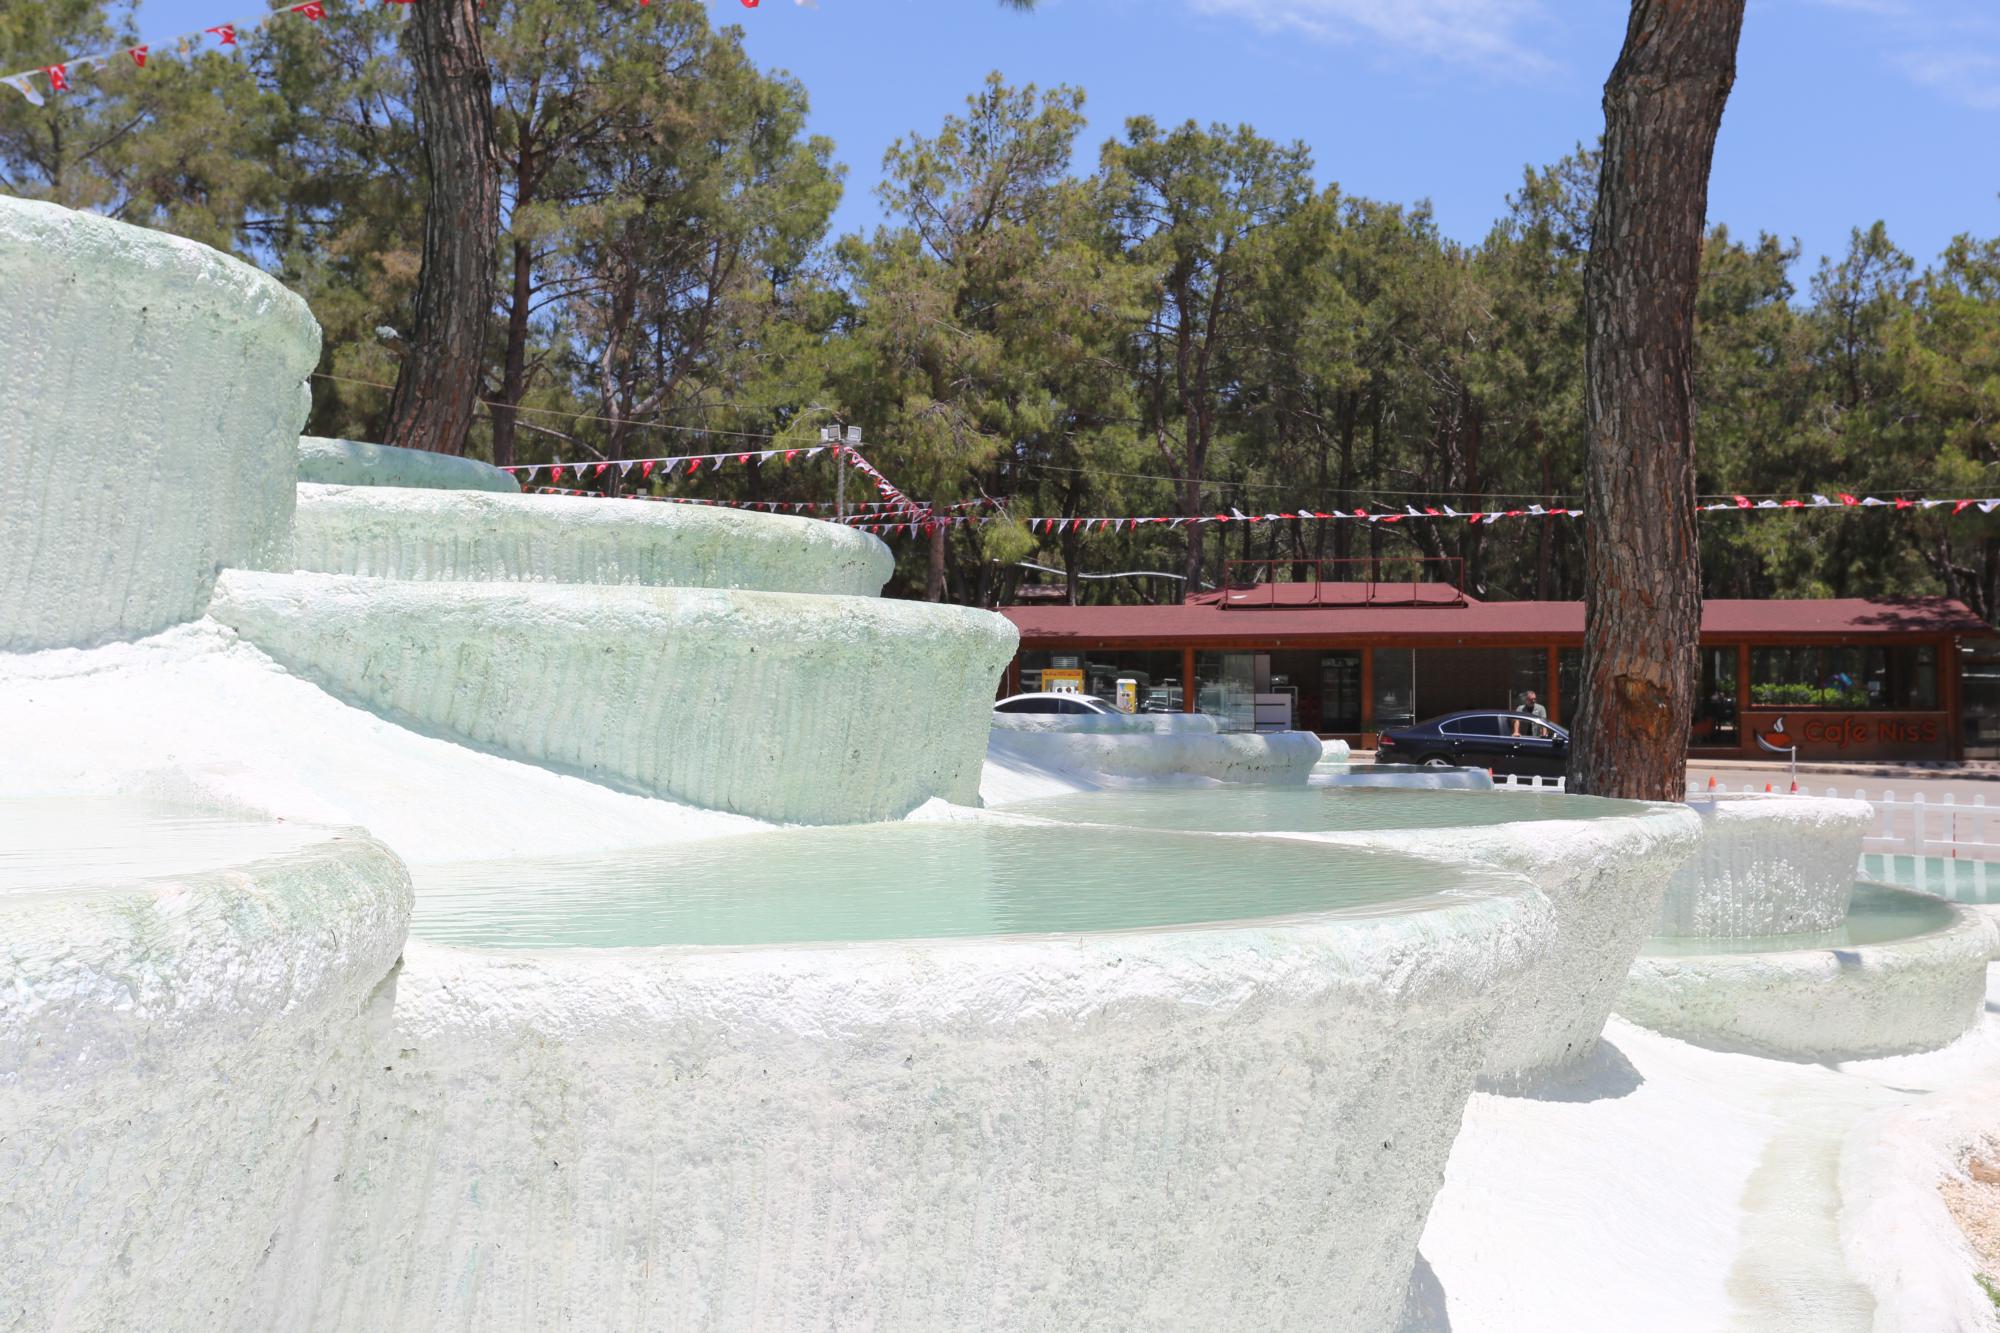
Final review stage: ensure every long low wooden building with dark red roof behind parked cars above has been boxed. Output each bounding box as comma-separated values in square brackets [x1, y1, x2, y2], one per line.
[1002, 582, 2000, 761]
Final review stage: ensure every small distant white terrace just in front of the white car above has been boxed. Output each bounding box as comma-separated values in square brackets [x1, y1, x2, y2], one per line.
[988, 713, 1322, 787]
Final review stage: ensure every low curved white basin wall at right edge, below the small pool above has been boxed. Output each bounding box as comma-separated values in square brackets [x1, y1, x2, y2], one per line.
[1618, 889, 1994, 1061]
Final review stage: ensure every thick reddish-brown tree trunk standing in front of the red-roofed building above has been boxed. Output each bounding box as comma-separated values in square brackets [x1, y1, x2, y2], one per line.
[1570, 0, 1744, 801]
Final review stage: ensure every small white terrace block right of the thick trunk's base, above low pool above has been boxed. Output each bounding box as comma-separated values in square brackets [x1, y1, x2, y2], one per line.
[1658, 797, 1874, 939]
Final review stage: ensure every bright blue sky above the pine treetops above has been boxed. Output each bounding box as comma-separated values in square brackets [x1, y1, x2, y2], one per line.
[125, 0, 2000, 274]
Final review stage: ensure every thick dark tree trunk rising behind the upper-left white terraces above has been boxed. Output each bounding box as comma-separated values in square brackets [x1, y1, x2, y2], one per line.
[388, 0, 500, 454]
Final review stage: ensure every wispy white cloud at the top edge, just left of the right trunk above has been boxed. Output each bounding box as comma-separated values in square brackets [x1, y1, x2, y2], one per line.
[1190, 0, 1550, 72]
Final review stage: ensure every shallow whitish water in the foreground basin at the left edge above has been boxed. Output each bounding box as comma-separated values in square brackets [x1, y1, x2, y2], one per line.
[0, 797, 328, 895]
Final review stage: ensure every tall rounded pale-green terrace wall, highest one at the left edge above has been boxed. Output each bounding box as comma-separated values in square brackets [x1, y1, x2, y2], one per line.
[0, 196, 320, 650]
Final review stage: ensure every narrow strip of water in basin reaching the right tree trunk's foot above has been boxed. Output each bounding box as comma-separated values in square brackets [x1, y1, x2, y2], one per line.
[1006, 787, 1664, 833]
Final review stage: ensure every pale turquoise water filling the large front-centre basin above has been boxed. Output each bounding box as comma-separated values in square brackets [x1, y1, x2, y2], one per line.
[410, 823, 1524, 949]
